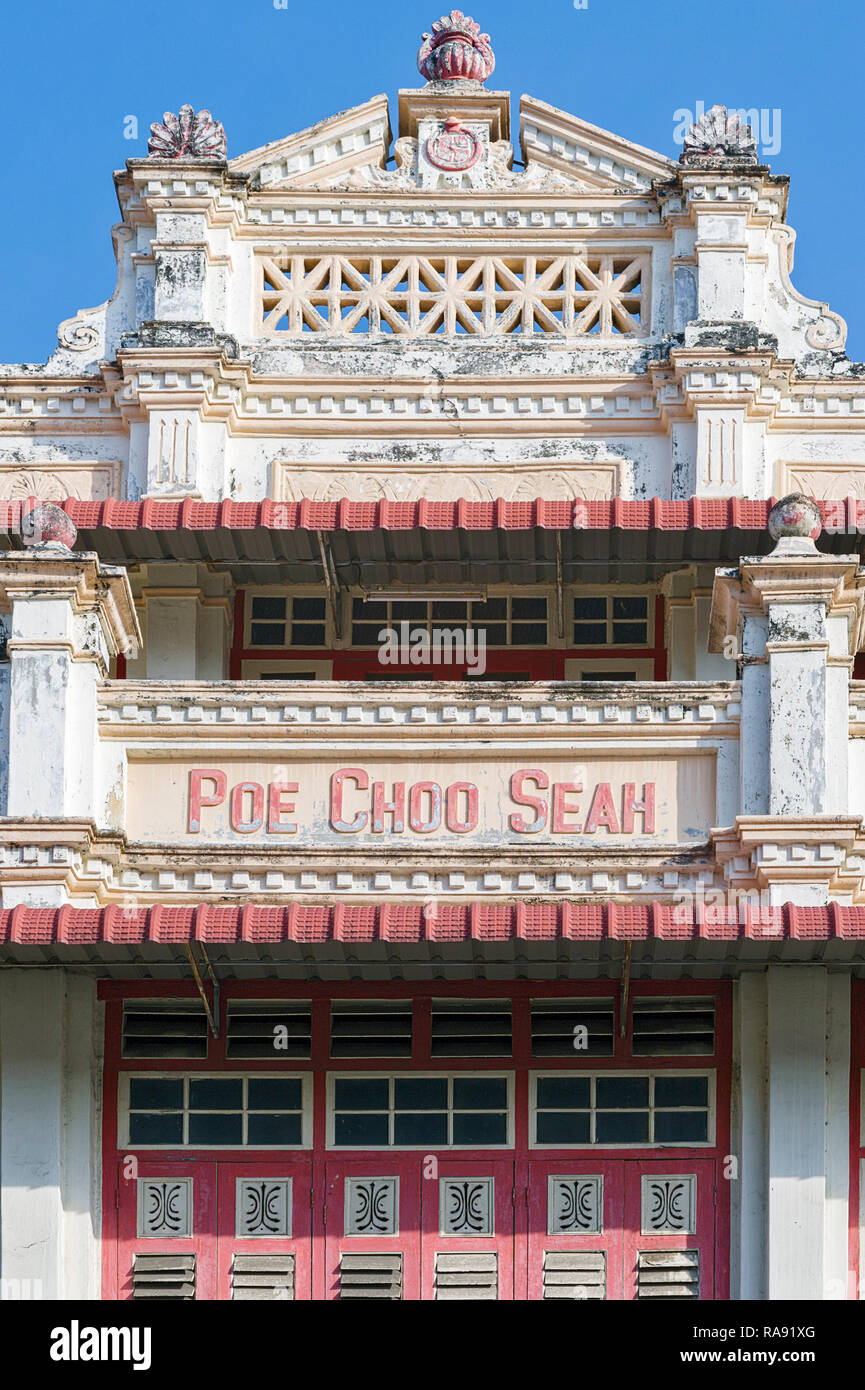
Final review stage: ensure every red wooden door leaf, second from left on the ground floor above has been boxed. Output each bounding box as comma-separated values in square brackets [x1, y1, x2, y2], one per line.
[217, 1158, 312, 1301]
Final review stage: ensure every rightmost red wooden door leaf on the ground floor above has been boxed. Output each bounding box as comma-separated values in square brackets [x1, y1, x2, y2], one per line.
[623, 1158, 716, 1301]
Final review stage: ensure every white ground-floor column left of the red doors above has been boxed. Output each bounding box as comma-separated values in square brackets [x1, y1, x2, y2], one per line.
[0, 969, 102, 1298]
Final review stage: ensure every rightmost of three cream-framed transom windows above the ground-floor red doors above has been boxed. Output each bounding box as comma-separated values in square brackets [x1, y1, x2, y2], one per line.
[533, 1072, 712, 1147]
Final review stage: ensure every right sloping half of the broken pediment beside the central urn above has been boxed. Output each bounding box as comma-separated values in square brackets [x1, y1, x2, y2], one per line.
[520, 96, 677, 193]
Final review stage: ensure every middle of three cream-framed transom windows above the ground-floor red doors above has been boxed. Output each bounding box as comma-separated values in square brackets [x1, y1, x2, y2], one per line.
[331, 1074, 512, 1148]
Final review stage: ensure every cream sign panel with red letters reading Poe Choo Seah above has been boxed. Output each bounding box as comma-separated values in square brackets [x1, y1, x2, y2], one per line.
[127, 752, 715, 848]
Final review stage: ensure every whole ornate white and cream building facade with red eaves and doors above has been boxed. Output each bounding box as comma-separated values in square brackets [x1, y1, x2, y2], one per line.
[0, 11, 865, 1301]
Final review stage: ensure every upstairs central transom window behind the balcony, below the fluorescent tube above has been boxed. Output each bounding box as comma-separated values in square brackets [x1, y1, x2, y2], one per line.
[352, 595, 547, 646]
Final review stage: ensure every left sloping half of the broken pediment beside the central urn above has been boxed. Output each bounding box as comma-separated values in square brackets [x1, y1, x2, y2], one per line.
[229, 93, 391, 188]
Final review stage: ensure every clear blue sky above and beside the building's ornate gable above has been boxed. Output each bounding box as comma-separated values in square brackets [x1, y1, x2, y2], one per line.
[0, 0, 865, 361]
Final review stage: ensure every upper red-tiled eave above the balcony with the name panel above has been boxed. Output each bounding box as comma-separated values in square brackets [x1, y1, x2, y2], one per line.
[0, 498, 865, 587]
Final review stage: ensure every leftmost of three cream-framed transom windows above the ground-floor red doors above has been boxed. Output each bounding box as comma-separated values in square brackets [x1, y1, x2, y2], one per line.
[121, 1073, 309, 1148]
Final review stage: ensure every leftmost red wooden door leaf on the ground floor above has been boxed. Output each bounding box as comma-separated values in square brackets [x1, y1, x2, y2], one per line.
[117, 1155, 217, 1301]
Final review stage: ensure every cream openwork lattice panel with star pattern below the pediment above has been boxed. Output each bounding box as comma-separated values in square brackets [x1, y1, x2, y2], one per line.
[259, 252, 649, 338]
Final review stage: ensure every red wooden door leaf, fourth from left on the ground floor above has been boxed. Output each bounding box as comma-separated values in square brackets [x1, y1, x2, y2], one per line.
[421, 1158, 515, 1300]
